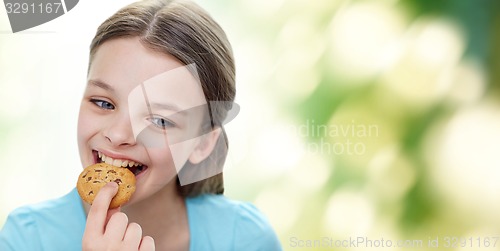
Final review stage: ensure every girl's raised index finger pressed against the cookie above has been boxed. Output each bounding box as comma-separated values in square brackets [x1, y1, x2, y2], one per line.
[87, 182, 118, 234]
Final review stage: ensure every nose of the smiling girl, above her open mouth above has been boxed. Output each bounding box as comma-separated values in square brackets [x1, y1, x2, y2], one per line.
[103, 114, 135, 147]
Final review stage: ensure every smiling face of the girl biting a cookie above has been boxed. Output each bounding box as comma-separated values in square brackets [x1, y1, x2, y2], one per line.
[78, 38, 208, 204]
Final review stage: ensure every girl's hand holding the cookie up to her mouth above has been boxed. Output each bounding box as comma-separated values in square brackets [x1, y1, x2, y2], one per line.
[82, 182, 155, 251]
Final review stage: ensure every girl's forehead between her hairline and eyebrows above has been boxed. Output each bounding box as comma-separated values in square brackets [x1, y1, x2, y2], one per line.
[88, 37, 206, 109]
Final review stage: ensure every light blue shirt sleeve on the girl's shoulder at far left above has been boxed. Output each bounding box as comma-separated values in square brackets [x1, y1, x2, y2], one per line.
[0, 208, 40, 251]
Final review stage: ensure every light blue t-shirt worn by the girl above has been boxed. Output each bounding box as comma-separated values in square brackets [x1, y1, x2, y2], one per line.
[0, 189, 282, 251]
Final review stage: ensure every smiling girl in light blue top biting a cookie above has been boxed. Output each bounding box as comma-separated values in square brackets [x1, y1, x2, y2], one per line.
[0, 0, 281, 251]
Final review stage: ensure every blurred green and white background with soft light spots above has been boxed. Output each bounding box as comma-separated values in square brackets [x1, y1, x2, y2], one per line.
[0, 0, 500, 250]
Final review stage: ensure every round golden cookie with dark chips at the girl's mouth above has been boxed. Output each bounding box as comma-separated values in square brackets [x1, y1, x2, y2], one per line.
[76, 163, 135, 208]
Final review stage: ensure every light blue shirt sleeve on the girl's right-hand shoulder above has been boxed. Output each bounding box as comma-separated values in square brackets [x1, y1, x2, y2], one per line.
[233, 203, 283, 251]
